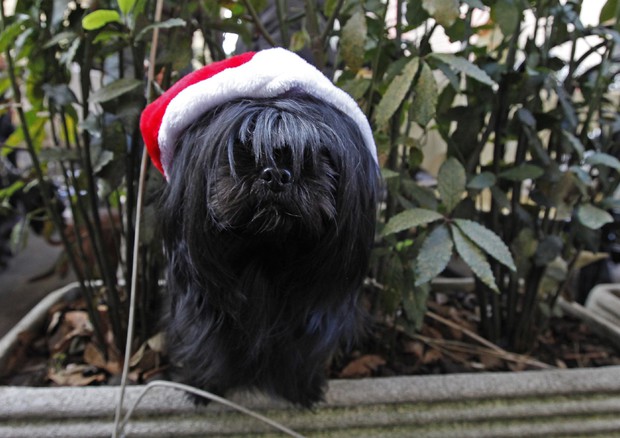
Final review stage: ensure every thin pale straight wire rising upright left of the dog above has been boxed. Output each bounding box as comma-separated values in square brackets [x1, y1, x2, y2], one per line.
[112, 0, 164, 438]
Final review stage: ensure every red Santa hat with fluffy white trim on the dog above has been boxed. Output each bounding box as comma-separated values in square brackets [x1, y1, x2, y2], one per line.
[140, 48, 377, 179]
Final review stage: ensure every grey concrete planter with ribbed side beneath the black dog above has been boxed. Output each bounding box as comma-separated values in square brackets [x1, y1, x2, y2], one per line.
[0, 282, 620, 438]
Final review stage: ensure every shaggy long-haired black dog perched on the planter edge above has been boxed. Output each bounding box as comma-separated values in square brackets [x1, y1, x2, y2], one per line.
[161, 91, 379, 407]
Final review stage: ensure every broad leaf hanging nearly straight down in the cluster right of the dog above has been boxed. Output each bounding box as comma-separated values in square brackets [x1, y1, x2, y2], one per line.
[415, 224, 453, 286]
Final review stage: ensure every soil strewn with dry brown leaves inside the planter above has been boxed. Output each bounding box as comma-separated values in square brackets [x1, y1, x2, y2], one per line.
[0, 291, 620, 386]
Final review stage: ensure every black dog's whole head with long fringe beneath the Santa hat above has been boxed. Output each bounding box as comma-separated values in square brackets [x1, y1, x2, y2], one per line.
[165, 93, 376, 246]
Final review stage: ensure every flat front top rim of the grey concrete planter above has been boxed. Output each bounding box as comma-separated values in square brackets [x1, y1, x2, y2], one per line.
[0, 366, 620, 420]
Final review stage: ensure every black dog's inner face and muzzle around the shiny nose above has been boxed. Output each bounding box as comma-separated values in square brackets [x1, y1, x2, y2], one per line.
[208, 123, 339, 238]
